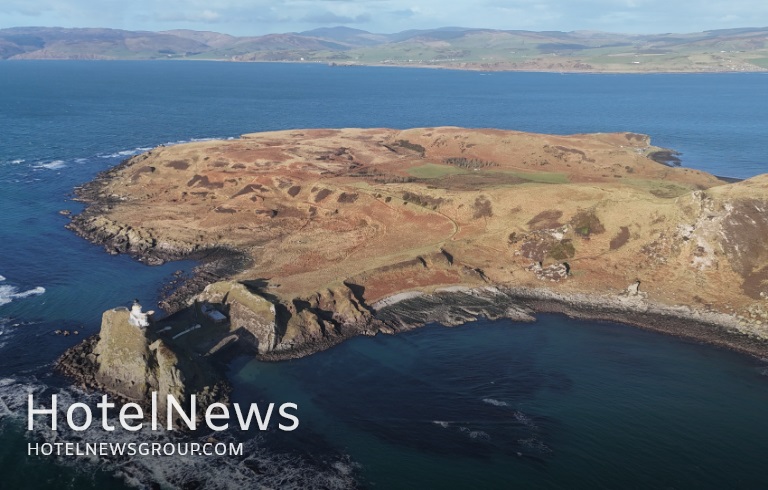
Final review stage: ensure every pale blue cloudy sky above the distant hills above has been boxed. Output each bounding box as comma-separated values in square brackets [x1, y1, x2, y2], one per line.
[0, 0, 768, 36]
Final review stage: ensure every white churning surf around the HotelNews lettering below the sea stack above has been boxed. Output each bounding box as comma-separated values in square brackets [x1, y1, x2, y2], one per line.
[0, 378, 359, 490]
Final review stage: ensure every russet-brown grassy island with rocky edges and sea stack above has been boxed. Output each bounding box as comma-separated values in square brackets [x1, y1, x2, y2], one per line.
[60, 127, 768, 410]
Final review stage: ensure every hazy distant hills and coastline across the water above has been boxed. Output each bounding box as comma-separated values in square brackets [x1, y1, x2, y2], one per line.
[0, 26, 768, 72]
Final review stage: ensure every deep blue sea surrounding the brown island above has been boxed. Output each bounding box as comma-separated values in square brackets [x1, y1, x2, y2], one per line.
[0, 61, 768, 489]
